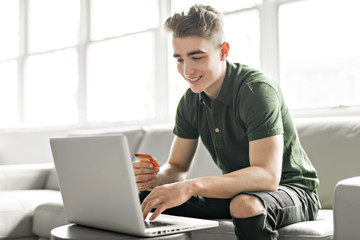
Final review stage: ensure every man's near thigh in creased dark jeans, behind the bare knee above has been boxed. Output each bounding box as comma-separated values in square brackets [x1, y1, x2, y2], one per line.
[242, 185, 318, 229]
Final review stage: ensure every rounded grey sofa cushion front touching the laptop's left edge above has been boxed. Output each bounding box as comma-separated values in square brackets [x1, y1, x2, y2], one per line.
[33, 202, 68, 239]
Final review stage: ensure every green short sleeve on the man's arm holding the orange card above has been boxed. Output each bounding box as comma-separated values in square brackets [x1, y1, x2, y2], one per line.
[173, 91, 199, 139]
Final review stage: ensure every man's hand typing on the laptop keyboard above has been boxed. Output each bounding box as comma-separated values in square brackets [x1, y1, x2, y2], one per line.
[141, 181, 192, 220]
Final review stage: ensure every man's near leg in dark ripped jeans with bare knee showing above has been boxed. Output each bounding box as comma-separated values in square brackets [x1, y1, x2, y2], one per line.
[230, 186, 318, 240]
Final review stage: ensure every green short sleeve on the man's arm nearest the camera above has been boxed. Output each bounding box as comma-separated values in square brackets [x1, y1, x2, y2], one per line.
[239, 81, 284, 141]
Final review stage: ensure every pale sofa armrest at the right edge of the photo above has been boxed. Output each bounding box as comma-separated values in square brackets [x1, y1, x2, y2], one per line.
[333, 176, 360, 240]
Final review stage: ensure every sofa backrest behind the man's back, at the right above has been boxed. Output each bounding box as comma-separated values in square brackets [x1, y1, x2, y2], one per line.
[295, 118, 360, 209]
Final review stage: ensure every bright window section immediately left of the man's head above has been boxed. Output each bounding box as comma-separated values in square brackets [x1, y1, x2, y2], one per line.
[86, 0, 159, 123]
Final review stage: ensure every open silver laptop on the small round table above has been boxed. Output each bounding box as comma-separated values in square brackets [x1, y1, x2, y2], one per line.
[50, 135, 218, 237]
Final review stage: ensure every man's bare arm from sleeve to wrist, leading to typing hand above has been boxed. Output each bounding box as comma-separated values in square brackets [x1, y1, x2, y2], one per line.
[188, 134, 284, 198]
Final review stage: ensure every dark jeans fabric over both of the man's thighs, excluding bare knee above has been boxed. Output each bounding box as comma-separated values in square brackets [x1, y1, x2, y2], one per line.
[140, 185, 319, 229]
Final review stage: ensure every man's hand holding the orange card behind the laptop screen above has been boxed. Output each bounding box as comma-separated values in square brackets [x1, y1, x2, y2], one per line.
[132, 161, 160, 191]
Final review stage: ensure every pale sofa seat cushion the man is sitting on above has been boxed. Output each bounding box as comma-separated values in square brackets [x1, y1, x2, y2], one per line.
[191, 210, 333, 240]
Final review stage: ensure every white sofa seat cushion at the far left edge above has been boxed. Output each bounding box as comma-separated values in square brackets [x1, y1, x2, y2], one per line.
[0, 190, 62, 239]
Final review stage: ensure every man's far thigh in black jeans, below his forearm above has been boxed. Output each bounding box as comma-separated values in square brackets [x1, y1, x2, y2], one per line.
[139, 191, 231, 219]
